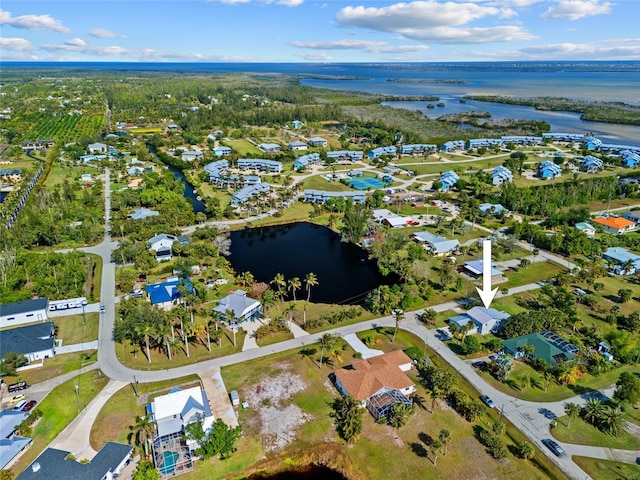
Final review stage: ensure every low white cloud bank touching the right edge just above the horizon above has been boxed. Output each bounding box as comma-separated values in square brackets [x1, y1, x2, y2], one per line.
[519, 38, 640, 60]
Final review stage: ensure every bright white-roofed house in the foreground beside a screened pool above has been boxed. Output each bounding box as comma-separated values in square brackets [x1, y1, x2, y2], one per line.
[147, 387, 215, 451]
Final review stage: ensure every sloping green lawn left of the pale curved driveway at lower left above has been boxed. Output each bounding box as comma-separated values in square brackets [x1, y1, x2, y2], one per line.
[11, 370, 109, 474]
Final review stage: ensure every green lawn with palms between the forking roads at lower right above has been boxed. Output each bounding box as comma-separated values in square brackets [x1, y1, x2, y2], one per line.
[551, 416, 640, 451]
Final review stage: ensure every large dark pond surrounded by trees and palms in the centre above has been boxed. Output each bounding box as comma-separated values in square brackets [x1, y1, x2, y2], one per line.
[229, 223, 396, 305]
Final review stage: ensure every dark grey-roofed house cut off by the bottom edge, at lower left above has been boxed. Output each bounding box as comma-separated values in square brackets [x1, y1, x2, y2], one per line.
[16, 442, 133, 480]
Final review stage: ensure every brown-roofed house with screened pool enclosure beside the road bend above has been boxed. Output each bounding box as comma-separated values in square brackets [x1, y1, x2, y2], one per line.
[335, 350, 416, 420]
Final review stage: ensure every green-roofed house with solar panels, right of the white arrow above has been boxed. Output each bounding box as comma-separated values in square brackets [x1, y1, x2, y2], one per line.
[502, 332, 578, 366]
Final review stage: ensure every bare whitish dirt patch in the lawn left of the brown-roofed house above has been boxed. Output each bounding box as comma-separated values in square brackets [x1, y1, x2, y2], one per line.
[245, 372, 313, 452]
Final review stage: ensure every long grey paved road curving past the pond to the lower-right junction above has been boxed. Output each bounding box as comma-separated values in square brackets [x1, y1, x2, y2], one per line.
[74, 168, 637, 480]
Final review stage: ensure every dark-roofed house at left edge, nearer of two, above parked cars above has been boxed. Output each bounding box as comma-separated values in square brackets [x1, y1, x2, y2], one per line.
[0, 322, 56, 362]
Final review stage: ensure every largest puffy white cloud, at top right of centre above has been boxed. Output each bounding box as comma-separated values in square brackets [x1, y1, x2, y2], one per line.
[336, 0, 535, 44]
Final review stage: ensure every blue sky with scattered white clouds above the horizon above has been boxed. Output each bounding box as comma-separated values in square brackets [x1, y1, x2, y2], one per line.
[0, 0, 640, 62]
